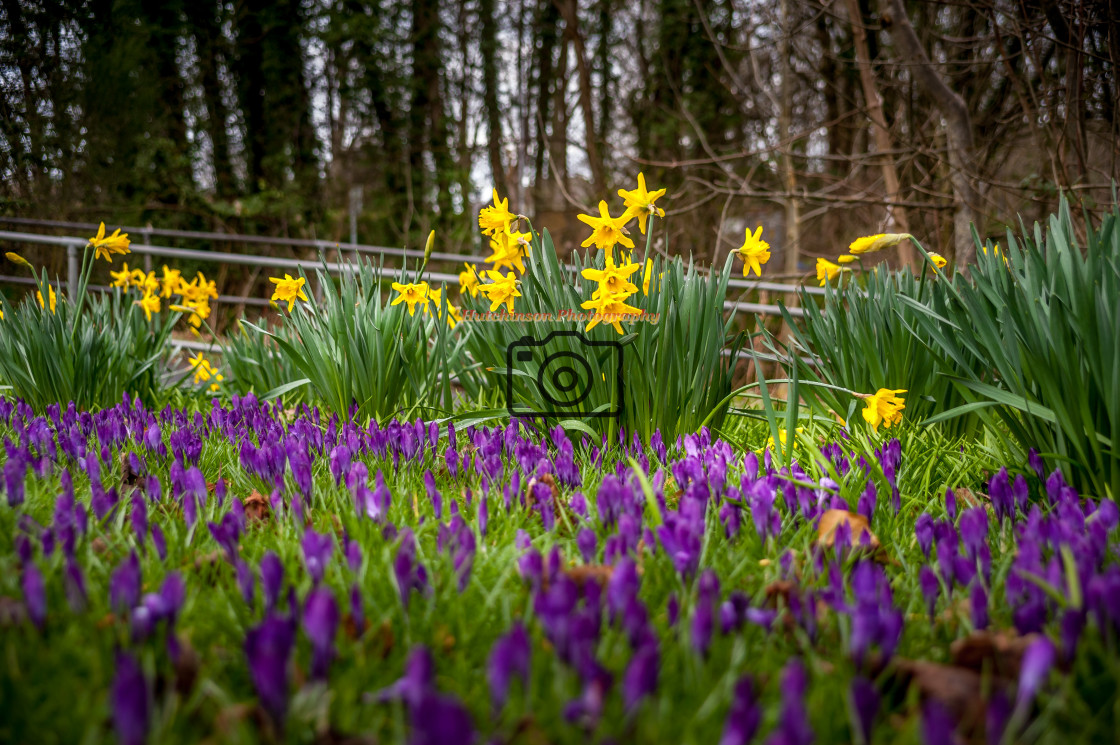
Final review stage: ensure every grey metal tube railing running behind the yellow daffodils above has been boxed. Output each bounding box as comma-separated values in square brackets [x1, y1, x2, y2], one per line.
[0, 217, 810, 317]
